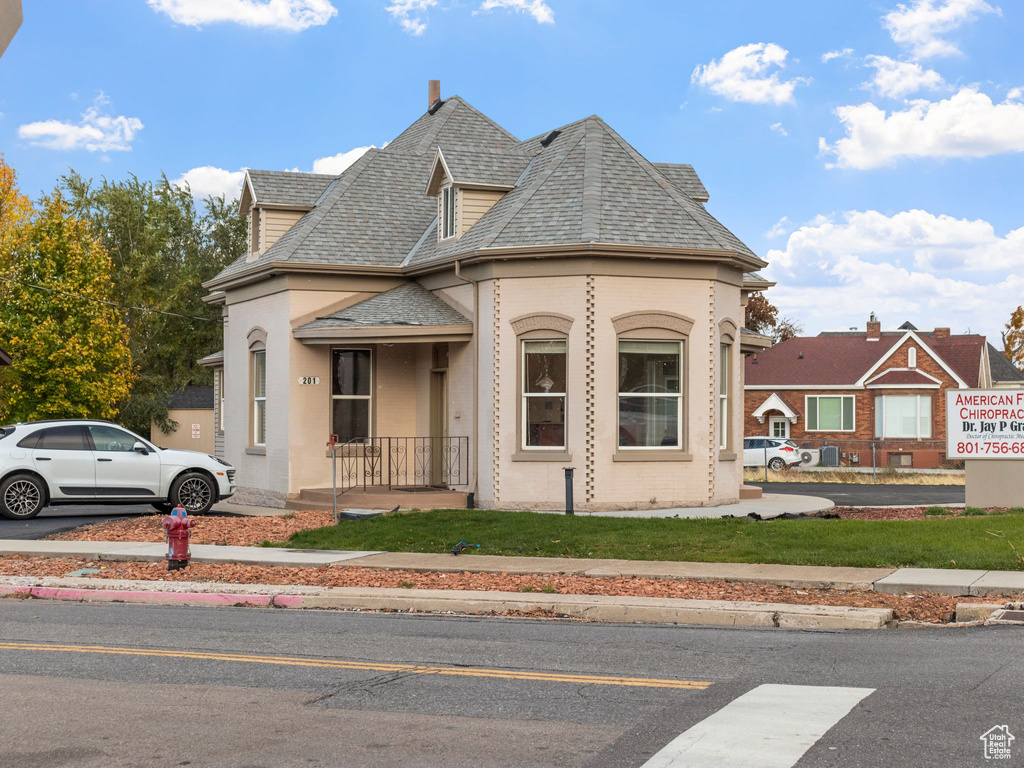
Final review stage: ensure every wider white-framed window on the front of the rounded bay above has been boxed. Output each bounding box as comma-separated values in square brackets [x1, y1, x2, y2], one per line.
[618, 339, 683, 449]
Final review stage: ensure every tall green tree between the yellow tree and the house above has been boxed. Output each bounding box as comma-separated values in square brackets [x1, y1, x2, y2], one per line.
[61, 172, 246, 431]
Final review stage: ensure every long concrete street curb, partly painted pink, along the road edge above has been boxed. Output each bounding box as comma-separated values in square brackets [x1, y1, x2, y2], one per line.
[0, 577, 893, 630]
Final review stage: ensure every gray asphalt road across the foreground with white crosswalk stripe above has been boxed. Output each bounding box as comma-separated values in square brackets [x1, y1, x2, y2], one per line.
[0, 600, 1024, 768]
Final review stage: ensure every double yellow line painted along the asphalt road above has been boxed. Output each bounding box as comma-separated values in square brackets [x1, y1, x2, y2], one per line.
[0, 642, 711, 690]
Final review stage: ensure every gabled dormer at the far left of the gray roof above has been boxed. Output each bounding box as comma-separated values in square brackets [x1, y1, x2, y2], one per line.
[239, 169, 335, 261]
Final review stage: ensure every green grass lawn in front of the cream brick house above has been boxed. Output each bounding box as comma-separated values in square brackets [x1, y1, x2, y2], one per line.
[276, 510, 1024, 570]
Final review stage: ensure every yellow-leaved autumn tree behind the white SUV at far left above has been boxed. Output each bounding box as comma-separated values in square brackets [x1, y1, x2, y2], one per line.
[0, 190, 133, 421]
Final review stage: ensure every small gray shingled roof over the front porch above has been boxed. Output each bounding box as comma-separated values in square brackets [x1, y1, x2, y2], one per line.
[296, 283, 472, 330]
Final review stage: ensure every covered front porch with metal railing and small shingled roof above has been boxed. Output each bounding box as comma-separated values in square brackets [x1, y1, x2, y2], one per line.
[291, 284, 474, 499]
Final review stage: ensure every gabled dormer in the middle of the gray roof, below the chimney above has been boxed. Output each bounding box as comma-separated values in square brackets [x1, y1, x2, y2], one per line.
[426, 147, 529, 242]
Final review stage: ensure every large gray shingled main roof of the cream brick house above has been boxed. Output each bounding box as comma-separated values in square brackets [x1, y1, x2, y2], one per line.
[217, 96, 754, 280]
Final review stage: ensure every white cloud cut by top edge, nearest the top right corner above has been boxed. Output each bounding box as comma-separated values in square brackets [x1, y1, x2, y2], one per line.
[882, 0, 1001, 58]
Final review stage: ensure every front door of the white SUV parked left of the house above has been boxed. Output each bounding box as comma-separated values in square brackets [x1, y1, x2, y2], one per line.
[87, 424, 160, 499]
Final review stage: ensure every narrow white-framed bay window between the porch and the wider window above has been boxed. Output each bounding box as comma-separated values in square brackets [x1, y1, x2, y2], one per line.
[521, 339, 566, 451]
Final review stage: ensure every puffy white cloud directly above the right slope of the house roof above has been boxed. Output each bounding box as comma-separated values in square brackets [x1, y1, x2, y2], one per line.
[690, 43, 810, 104]
